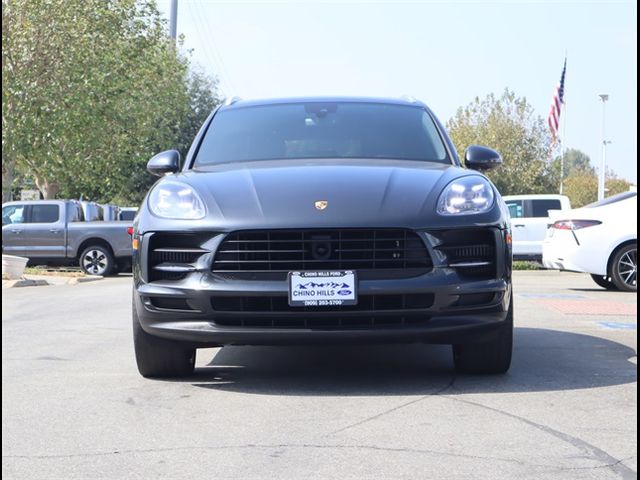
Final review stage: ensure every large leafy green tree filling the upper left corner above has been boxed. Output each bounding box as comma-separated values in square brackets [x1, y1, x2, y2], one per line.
[2, 0, 217, 202]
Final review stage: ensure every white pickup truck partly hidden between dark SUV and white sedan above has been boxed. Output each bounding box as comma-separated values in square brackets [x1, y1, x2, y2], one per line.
[502, 195, 571, 261]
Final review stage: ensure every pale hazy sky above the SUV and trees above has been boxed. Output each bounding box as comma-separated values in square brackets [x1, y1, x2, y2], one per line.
[158, 0, 638, 183]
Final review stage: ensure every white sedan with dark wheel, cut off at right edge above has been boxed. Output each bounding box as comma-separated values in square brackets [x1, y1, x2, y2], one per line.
[543, 192, 638, 292]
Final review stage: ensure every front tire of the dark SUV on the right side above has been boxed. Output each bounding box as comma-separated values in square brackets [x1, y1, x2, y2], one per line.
[453, 296, 513, 374]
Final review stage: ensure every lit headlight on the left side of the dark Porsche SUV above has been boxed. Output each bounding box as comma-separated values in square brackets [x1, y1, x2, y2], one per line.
[148, 182, 204, 220]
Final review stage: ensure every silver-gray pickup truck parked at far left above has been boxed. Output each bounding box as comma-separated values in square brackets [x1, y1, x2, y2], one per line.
[2, 200, 133, 275]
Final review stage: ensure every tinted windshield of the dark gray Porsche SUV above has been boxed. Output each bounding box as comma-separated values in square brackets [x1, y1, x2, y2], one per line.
[195, 102, 450, 167]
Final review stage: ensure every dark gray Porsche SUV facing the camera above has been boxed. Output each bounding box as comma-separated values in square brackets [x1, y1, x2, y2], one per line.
[133, 98, 513, 377]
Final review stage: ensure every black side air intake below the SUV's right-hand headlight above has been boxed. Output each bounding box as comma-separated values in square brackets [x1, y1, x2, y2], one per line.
[429, 228, 497, 279]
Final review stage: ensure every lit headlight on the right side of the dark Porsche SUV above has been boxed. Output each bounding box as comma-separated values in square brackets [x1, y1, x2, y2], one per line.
[437, 175, 495, 215]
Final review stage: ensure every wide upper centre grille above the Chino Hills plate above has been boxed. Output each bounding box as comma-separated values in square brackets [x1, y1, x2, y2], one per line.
[212, 229, 432, 278]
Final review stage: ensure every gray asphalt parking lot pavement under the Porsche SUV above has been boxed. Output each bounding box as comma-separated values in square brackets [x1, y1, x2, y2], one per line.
[2, 271, 637, 479]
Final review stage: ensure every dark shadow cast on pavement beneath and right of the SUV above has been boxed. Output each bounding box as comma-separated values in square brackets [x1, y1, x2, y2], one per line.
[182, 328, 637, 396]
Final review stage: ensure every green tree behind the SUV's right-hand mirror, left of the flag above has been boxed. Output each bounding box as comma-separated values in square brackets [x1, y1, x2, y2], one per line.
[447, 89, 560, 195]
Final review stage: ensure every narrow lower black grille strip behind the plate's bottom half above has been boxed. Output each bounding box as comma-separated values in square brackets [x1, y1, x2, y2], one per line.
[211, 293, 433, 313]
